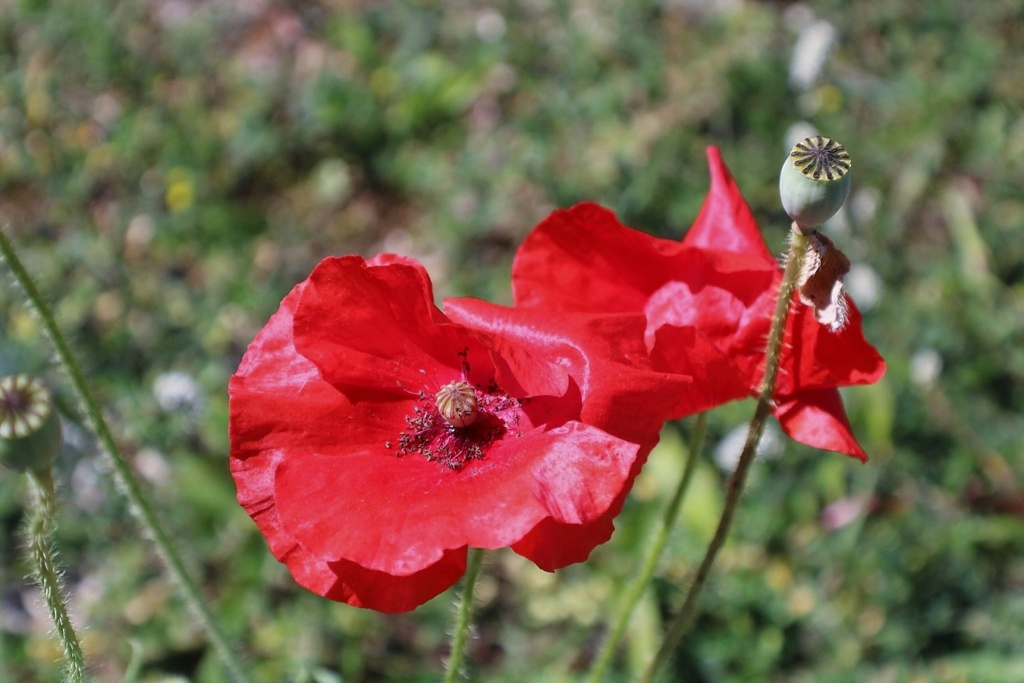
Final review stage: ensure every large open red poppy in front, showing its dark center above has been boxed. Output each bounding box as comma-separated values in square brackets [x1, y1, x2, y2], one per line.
[229, 256, 688, 611]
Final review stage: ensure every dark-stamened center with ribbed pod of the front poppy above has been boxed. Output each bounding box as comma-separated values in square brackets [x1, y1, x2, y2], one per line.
[385, 380, 519, 470]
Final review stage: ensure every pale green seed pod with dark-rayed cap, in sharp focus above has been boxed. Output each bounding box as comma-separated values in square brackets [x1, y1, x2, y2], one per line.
[778, 135, 851, 231]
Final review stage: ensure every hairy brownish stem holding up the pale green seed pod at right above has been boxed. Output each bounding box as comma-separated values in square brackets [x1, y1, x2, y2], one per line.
[637, 229, 808, 683]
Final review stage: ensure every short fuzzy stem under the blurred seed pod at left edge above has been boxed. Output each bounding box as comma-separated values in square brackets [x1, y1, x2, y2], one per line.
[26, 468, 86, 683]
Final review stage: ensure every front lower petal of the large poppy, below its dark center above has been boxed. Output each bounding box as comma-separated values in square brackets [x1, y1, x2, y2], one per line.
[274, 423, 638, 575]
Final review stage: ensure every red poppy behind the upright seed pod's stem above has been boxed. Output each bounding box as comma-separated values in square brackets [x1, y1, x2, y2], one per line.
[512, 147, 885, 460]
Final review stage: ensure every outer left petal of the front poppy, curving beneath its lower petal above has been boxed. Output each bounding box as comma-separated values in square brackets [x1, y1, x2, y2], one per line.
[229, 283, 465, 612]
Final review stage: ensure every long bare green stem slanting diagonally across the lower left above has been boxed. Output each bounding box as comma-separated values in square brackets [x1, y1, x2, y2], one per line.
[0, 229, 249, 683]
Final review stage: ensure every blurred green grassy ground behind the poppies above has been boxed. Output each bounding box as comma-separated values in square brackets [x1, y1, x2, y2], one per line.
[0, 0, 1024, 683]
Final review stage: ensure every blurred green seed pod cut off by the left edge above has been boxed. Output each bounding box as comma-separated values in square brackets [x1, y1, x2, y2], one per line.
[0, 375, 62, 472]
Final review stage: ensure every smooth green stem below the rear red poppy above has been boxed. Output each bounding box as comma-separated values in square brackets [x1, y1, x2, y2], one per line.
[587, 413, 708, 683]
